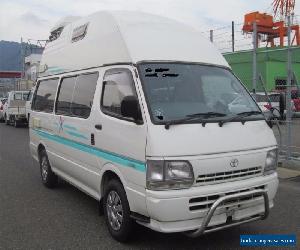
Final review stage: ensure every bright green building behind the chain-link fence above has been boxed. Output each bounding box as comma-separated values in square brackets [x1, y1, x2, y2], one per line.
[224, 47, 300, 91]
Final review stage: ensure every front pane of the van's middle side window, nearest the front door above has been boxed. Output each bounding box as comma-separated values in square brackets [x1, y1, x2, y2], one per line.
[71, 73, 98, 118]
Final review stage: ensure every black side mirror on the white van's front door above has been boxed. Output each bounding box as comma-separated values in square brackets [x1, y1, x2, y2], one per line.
[121, 96, 142, 124]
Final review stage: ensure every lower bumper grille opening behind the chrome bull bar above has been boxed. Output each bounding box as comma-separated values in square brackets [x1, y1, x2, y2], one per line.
[189, 186, 265, 211]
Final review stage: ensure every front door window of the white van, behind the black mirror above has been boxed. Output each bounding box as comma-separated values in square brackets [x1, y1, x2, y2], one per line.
[101, 69, 136, 118]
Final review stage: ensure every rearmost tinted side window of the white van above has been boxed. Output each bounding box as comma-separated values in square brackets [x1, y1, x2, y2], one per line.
[32, 78, 58, 113]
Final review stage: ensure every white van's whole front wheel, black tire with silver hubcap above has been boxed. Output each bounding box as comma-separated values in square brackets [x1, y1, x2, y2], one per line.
[103, 179, 133, 242]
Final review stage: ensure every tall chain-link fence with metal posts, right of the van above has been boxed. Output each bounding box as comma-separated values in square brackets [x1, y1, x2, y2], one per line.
[203, 16, 300, 166]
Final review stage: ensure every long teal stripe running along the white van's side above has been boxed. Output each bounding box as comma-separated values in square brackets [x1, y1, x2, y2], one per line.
[33, 129, 146, 172]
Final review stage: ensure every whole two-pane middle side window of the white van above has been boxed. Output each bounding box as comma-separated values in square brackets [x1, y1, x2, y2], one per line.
[56, 72, 98, 119]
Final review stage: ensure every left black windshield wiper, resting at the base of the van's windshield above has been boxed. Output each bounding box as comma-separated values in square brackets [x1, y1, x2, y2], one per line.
[165, 112, 226, 129]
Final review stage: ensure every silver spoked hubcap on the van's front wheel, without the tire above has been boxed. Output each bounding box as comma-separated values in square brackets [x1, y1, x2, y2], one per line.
[106, 191, 123, 231]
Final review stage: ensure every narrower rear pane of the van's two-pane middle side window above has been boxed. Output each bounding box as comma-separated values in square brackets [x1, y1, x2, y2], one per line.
[55, 77, 76, 115]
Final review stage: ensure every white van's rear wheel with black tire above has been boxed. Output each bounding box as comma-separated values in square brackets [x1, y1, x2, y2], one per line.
[39, 149, 58, 188]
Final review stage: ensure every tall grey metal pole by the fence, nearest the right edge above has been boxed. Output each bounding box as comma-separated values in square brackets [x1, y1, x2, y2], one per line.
[286, 15, 292, 160]
